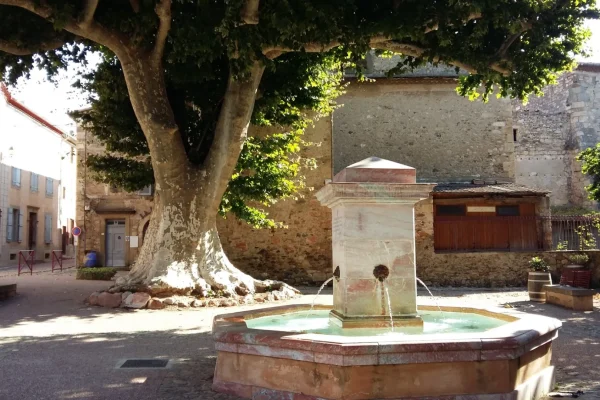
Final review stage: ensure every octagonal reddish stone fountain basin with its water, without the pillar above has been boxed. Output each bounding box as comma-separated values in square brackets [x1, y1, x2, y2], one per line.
[213, 305, 561, 400]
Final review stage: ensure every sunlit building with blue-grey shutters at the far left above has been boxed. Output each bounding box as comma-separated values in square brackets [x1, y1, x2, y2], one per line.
[0, 85, 76, 266]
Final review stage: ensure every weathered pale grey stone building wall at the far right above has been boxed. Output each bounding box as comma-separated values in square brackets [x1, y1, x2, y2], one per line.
[513, 64, 600, 208]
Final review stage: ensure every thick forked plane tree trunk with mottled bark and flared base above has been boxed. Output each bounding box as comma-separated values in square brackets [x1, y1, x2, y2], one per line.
[115, 54, 296, 295]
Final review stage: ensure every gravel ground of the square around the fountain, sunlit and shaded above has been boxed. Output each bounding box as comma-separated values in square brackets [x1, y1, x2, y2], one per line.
[0, 265, 600, 400]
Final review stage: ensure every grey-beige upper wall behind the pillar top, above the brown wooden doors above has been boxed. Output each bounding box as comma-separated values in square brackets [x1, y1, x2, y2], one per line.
[333, 78, 514, 182]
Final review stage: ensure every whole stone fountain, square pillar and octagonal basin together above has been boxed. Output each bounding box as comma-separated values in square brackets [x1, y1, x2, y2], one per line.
[213, 157, 561, 400]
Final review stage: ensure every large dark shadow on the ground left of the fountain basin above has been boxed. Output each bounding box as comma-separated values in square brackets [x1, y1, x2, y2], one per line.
[0, 330, 235, 400]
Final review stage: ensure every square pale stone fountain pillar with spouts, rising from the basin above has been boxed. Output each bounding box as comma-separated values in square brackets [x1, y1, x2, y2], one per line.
[317, 157, 435, 327]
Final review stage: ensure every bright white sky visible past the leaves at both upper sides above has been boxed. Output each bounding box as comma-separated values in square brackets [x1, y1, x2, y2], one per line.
[11, 20, 600, 132]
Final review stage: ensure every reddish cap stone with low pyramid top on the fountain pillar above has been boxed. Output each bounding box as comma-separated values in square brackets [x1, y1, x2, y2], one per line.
[333, 157, 417, 184]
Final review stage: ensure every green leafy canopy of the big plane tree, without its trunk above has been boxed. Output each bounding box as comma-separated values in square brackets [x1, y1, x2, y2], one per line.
[0, 0, 597, 226]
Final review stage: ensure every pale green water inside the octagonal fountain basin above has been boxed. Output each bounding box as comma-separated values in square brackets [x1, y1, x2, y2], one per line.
[246, 310, 507, 336]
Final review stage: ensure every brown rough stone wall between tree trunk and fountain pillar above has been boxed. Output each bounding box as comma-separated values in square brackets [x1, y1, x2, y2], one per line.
[218, 118, 331, 285]
